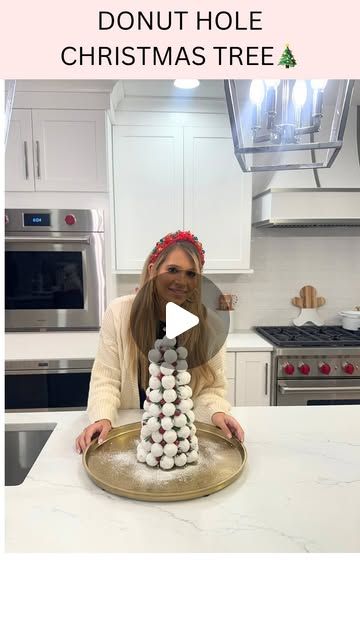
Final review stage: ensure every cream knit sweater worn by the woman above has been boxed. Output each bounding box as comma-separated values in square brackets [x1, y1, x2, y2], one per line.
[88, 294, 230, 426]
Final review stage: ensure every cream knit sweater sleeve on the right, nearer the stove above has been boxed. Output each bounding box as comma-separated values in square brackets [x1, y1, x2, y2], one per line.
[193, 347, 231, 424]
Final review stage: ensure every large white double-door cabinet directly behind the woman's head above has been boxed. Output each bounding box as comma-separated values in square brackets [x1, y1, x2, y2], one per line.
[113, 120, 251, 273]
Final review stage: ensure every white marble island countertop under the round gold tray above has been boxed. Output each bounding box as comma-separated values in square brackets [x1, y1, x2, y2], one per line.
[5, 405, 360, 552]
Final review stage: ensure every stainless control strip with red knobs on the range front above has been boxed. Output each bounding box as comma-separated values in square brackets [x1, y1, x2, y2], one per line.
[277, 352, 360, 379]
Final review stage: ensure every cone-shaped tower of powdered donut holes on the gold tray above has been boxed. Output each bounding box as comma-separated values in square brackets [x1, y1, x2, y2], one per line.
[137, 337, 199, 469]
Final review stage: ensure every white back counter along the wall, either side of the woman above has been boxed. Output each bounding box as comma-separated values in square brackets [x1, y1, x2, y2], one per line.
[5, 331, 273, 361]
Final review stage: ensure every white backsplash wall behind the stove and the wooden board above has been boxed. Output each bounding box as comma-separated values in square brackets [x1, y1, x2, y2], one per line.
[111, 228, 360, 330]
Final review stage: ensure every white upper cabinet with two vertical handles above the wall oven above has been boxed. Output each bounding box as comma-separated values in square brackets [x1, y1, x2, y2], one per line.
[6, 109, 107, 191]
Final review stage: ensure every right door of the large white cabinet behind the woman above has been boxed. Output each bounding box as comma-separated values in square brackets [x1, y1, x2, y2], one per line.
[184, 127, 251, 273]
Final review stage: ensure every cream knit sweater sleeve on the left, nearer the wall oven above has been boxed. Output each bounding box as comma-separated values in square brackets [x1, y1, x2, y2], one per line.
[87, 304, 122, 424]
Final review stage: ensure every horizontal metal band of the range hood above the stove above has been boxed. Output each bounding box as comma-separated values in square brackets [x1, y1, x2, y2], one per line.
[253, 188, 360, 227]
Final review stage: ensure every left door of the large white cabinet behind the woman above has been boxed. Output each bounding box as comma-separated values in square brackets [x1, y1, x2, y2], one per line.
[113, 125, 183, 273]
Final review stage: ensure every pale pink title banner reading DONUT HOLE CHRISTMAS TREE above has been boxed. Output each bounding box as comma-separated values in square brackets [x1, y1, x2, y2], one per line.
[0, 0, 360, 79]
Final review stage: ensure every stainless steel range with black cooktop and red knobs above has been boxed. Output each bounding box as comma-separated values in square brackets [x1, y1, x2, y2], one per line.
[255, 326, 360, 406]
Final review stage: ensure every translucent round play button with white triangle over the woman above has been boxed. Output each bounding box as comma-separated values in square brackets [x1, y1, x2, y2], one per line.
[130, 270, 230, 369]
